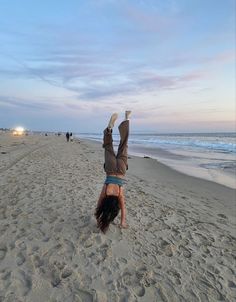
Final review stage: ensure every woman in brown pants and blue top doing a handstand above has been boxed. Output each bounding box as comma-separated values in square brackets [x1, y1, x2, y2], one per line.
[95, 111, 131, 233]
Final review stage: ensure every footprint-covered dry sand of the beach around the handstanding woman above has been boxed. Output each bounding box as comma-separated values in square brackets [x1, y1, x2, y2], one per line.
[0, 133, 236, 302]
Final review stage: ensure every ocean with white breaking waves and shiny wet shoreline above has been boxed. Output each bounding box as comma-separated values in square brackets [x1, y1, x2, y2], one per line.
[77, 132, 236, 188]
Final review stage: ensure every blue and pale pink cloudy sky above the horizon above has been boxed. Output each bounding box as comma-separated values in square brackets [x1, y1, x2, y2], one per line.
[0, 0, 236, 133]
